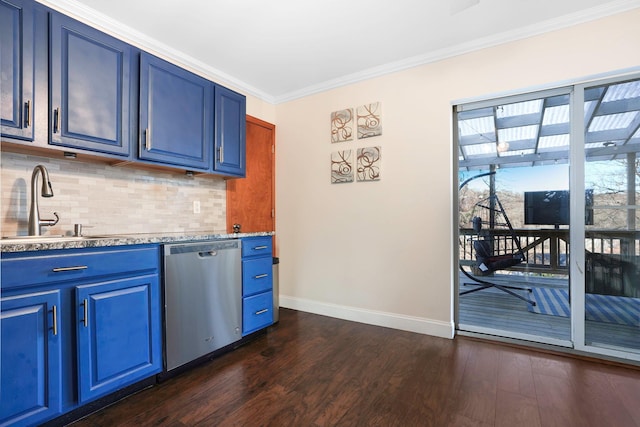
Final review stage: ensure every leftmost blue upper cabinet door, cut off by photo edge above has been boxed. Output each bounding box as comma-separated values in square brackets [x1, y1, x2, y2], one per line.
[0, 0, 35, 141]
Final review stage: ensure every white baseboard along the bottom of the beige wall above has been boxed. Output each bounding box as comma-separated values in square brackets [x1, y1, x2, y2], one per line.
[280, 295, 455, 338]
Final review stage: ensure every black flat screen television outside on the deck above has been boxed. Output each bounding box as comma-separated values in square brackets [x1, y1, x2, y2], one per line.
[524, 189, 593, 226]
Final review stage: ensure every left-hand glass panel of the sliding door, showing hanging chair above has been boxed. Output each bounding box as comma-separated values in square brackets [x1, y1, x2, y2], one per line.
[456, 89, 571, 346]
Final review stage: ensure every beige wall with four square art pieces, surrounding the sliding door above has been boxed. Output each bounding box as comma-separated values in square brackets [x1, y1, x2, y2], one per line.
[276, 9, 640, 336]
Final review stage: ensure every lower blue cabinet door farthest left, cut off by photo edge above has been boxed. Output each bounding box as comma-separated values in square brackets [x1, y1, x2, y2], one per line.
[0, 291, 61, 425]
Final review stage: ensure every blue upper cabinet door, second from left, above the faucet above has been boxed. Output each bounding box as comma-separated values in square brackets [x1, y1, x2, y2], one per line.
[49, 12, 132, 156]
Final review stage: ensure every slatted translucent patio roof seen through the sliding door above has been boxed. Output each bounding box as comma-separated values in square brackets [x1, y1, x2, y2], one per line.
[458, 80, 640, 170]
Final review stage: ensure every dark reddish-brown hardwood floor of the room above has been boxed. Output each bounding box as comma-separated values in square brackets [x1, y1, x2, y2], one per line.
[74, 309, 640, 427]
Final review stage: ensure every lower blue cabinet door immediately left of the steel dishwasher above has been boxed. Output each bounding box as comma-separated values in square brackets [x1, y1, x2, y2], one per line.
[76, 274, 162, 404]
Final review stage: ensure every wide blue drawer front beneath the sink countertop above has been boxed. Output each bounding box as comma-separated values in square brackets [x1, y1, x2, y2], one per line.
[1, 247, 160, 291]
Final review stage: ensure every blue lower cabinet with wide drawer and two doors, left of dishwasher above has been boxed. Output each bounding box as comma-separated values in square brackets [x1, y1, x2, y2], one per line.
[0, 245, 162, 427]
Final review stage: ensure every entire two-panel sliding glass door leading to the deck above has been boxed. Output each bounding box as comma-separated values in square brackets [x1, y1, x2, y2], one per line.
[454, 76, 640, 360]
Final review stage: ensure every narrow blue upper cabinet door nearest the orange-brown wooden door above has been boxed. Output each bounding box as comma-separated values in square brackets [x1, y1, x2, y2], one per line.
[213, 85, 247, 177]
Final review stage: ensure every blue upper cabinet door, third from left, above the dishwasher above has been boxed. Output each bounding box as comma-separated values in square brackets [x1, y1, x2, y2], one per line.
[139, 53, 214, 170]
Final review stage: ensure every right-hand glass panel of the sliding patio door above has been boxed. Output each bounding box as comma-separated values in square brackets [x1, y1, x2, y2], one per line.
[583, 79, 640, 355]
